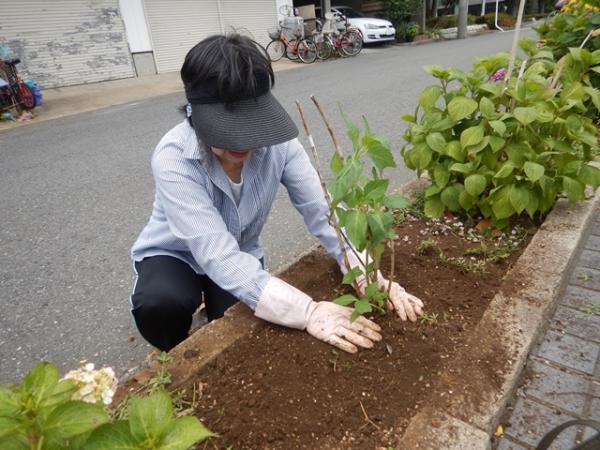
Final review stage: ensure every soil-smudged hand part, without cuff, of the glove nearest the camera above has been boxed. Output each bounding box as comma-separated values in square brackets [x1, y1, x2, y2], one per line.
[306, 302, 381, 353]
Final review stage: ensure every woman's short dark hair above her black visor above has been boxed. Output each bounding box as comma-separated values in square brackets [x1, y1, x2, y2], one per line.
[181, 34, 275, 103]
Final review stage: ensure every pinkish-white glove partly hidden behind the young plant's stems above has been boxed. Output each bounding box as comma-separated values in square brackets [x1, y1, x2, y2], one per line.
[340, 251, 423, 322]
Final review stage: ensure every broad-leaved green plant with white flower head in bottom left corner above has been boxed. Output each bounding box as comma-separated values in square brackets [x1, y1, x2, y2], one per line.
[0, 363, 212, 450]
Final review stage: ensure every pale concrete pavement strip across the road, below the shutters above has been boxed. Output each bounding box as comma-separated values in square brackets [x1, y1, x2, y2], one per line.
[0, 59, 302, 132]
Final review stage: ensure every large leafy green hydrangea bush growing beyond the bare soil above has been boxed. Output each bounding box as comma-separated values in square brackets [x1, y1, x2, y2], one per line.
[402, 50, 600, 228]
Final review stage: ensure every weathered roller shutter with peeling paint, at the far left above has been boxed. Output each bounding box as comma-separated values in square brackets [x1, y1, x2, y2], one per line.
[0, 0, 134, 88]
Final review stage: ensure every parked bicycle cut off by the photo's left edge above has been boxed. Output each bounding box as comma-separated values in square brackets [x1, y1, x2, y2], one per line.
[0, 58, 35, 113]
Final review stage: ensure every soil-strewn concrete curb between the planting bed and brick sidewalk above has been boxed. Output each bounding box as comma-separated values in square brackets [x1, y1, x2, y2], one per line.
[399, 192, 600, 450]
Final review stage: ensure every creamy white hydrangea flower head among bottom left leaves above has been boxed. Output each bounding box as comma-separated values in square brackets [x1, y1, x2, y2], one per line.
[63, 363, 118, 405]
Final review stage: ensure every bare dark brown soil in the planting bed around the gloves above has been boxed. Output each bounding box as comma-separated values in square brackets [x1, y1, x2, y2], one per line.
[177, 215, 528, 450]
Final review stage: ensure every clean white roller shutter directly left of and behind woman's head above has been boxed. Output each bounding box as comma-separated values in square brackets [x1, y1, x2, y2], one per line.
[144, 0, 221, 73]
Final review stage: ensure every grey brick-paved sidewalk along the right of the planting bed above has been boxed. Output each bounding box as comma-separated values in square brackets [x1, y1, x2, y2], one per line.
[495, 211, 600, 450]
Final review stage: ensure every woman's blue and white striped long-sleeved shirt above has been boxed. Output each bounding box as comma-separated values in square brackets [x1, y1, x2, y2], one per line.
[131, 120, 341, 310]
